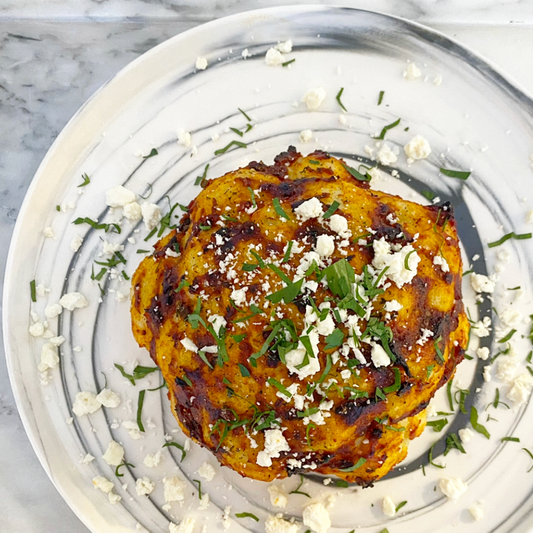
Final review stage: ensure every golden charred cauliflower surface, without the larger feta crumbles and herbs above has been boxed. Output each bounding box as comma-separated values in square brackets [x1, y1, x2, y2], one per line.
[132, 149, 469, 485]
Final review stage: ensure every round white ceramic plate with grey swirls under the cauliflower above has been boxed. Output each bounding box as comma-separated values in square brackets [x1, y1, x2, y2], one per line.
[4, 7, 533, 533]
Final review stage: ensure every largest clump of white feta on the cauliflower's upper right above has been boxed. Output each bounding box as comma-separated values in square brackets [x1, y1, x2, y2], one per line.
[372, 237, 420, 289]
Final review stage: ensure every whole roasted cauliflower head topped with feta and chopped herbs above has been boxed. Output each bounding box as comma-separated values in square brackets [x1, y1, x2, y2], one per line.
[131, 147, 469, 485]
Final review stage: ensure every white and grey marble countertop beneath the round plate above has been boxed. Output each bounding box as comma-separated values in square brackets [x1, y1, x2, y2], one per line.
[0, 0, 533, 533]
